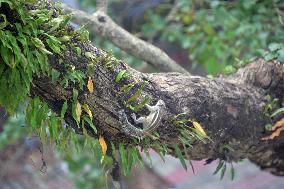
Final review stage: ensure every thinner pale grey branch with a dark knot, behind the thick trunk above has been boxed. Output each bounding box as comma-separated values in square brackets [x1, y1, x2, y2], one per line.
[62, 4, 188, 73]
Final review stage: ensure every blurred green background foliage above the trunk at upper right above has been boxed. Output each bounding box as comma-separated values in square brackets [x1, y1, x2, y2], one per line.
[142, 0, 284, 74]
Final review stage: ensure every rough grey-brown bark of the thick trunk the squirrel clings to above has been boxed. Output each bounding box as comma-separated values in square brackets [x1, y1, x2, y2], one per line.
[5, 0, 284, 175]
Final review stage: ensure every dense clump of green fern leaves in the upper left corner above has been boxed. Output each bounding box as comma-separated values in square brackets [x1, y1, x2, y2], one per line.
[0, 0, 70, 113]
